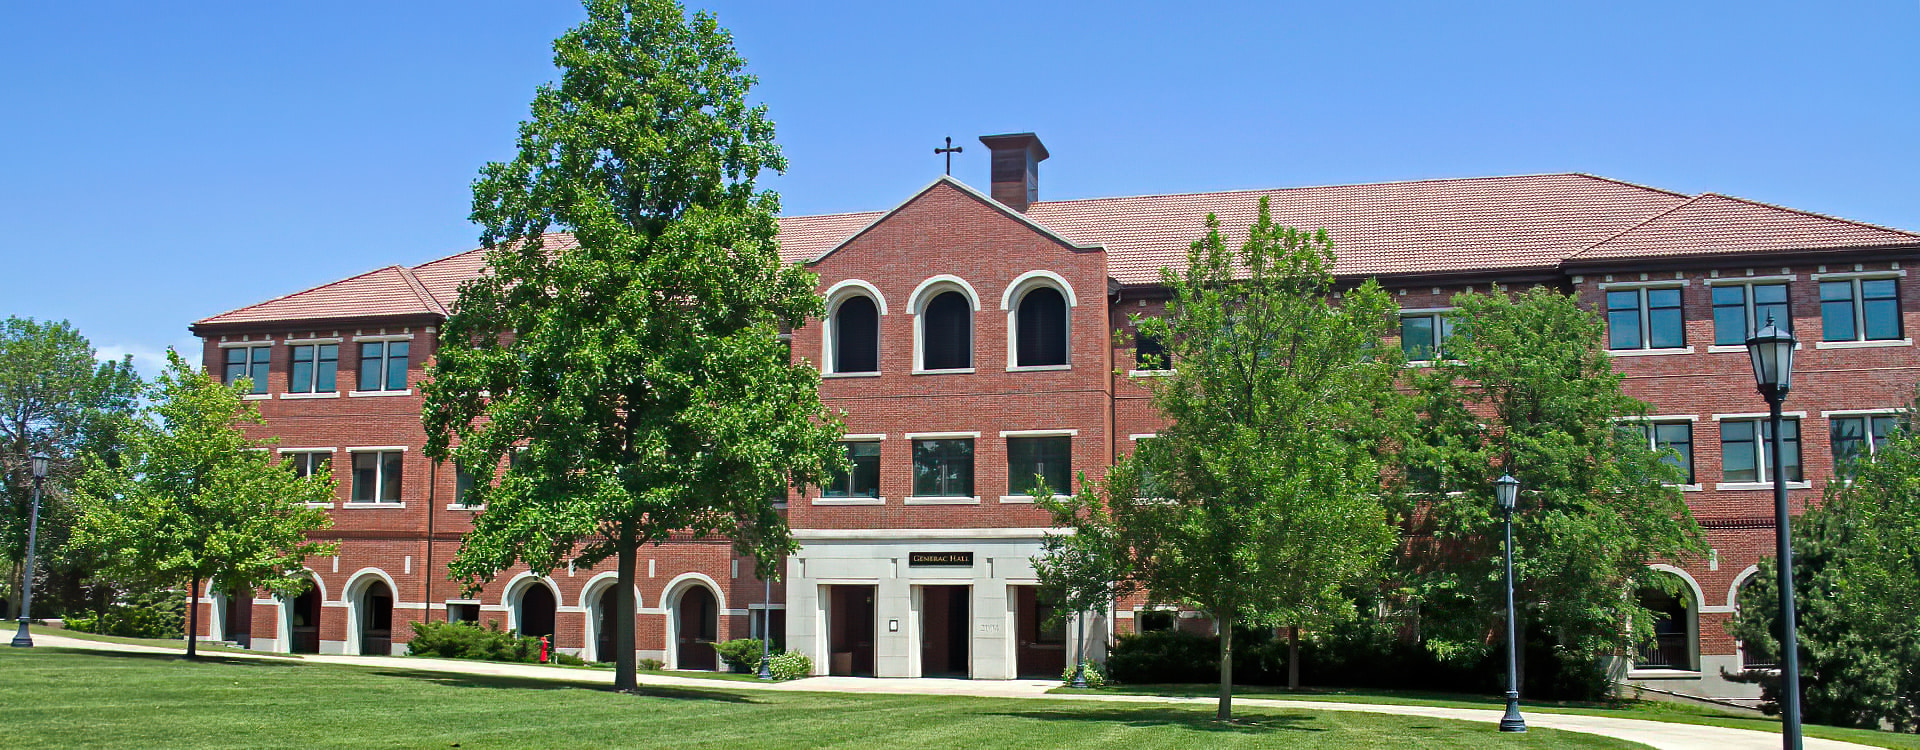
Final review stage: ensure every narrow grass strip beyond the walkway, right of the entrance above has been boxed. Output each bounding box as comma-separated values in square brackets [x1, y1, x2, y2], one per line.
[1052, 685, 1920, 750]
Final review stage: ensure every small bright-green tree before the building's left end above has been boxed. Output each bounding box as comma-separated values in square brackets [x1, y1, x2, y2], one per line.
[75, 349, 336, 658]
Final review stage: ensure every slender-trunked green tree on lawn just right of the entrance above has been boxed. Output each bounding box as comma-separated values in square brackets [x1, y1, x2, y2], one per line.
[1060, 199, 1400, 721]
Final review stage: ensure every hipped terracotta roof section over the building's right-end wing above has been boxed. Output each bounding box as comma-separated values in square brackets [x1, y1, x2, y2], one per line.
[1569, 194, 1920, 263]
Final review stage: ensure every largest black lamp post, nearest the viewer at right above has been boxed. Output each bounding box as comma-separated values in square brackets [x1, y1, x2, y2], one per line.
[1747, 316, 1801, 750]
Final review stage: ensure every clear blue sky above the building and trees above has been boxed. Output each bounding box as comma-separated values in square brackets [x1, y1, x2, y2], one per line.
[0, 0, 1920, 374]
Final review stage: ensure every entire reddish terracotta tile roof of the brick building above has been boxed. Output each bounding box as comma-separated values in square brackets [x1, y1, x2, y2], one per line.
[196, 175, 1920, 326]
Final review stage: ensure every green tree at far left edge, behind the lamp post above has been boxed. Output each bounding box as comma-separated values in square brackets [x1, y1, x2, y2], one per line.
[0, 316, 142, 614]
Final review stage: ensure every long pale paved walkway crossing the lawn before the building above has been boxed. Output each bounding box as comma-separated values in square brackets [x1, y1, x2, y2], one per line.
[33, 631, 1868, 750]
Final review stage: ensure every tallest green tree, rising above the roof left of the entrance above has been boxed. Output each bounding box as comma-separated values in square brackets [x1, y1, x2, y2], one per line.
[424, 0, 845, 691]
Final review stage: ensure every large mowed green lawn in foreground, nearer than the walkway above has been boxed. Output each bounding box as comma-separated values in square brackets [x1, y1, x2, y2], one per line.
[0, 648, 1640, 750]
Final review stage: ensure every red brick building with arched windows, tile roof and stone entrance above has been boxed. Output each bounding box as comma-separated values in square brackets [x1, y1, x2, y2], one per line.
[192, 134, 1920, 696]
